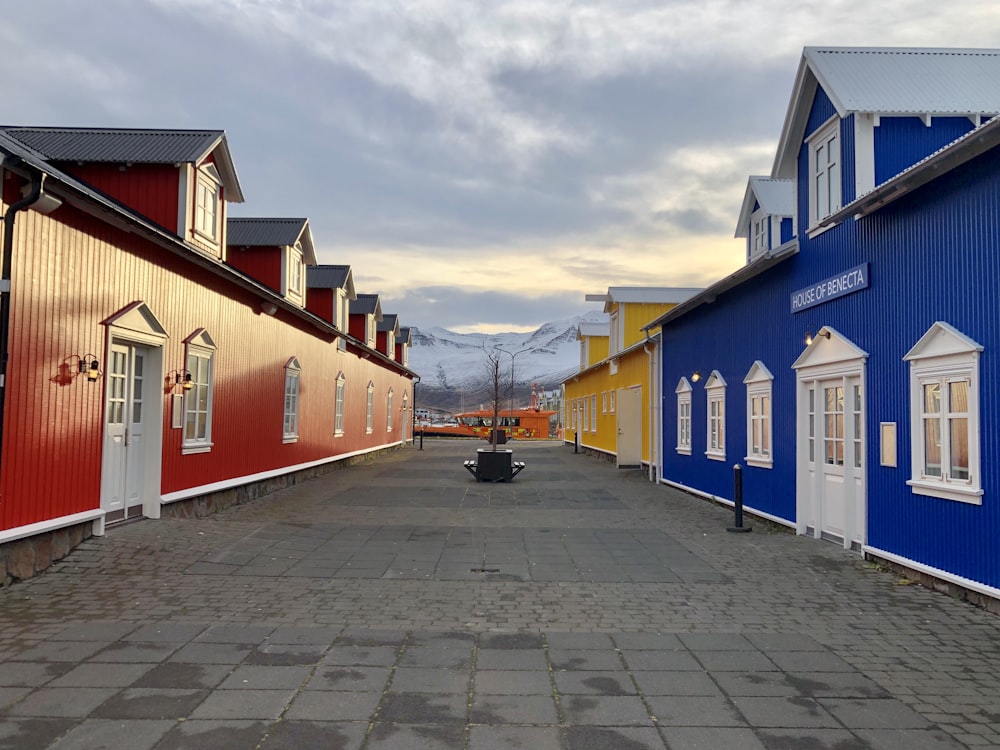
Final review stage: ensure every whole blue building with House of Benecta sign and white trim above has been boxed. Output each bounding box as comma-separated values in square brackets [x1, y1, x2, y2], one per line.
[649, 48, 1000, 599]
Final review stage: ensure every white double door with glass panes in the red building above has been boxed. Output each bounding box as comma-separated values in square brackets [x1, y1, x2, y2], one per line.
[101, 343, 149, 515]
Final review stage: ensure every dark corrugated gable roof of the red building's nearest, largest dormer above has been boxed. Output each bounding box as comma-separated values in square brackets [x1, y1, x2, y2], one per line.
[0, 126, 244, 203]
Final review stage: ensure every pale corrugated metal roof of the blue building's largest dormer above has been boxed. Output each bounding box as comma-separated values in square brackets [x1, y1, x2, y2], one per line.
[771, 47, 1000, 178]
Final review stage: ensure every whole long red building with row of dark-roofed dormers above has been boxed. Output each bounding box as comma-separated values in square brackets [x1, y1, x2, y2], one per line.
[0, 128, 416, 584]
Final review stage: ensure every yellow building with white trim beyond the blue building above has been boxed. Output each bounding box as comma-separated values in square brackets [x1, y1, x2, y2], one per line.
[562, 287, 701, 467]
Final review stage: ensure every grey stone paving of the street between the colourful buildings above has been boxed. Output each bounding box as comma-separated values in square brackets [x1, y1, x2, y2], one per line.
[0, 441, 1000, 750]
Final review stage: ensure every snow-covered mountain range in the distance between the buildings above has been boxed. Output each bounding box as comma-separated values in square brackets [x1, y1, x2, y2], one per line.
[409, 311, 607, 408]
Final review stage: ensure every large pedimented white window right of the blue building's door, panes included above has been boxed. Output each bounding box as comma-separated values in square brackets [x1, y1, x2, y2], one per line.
[903, 321, 983, 505]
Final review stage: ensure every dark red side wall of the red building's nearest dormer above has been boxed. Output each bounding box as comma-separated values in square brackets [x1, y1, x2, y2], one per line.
[60, 163, 184, 234]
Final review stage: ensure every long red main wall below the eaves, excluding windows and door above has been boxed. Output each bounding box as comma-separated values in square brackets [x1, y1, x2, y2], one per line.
[0, 180, 412, 529]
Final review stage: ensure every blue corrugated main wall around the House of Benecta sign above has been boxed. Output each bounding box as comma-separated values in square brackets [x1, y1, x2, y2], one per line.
[663, 138, 1000, 587]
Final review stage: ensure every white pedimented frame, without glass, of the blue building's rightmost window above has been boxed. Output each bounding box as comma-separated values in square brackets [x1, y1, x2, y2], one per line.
[903, 321, 983, 505]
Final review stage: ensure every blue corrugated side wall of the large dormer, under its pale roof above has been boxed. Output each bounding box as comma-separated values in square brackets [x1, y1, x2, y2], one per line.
[875, 117, 973, 185]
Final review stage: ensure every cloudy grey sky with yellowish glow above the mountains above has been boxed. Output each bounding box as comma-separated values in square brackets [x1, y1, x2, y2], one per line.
[0, 0, 1000, 332]
